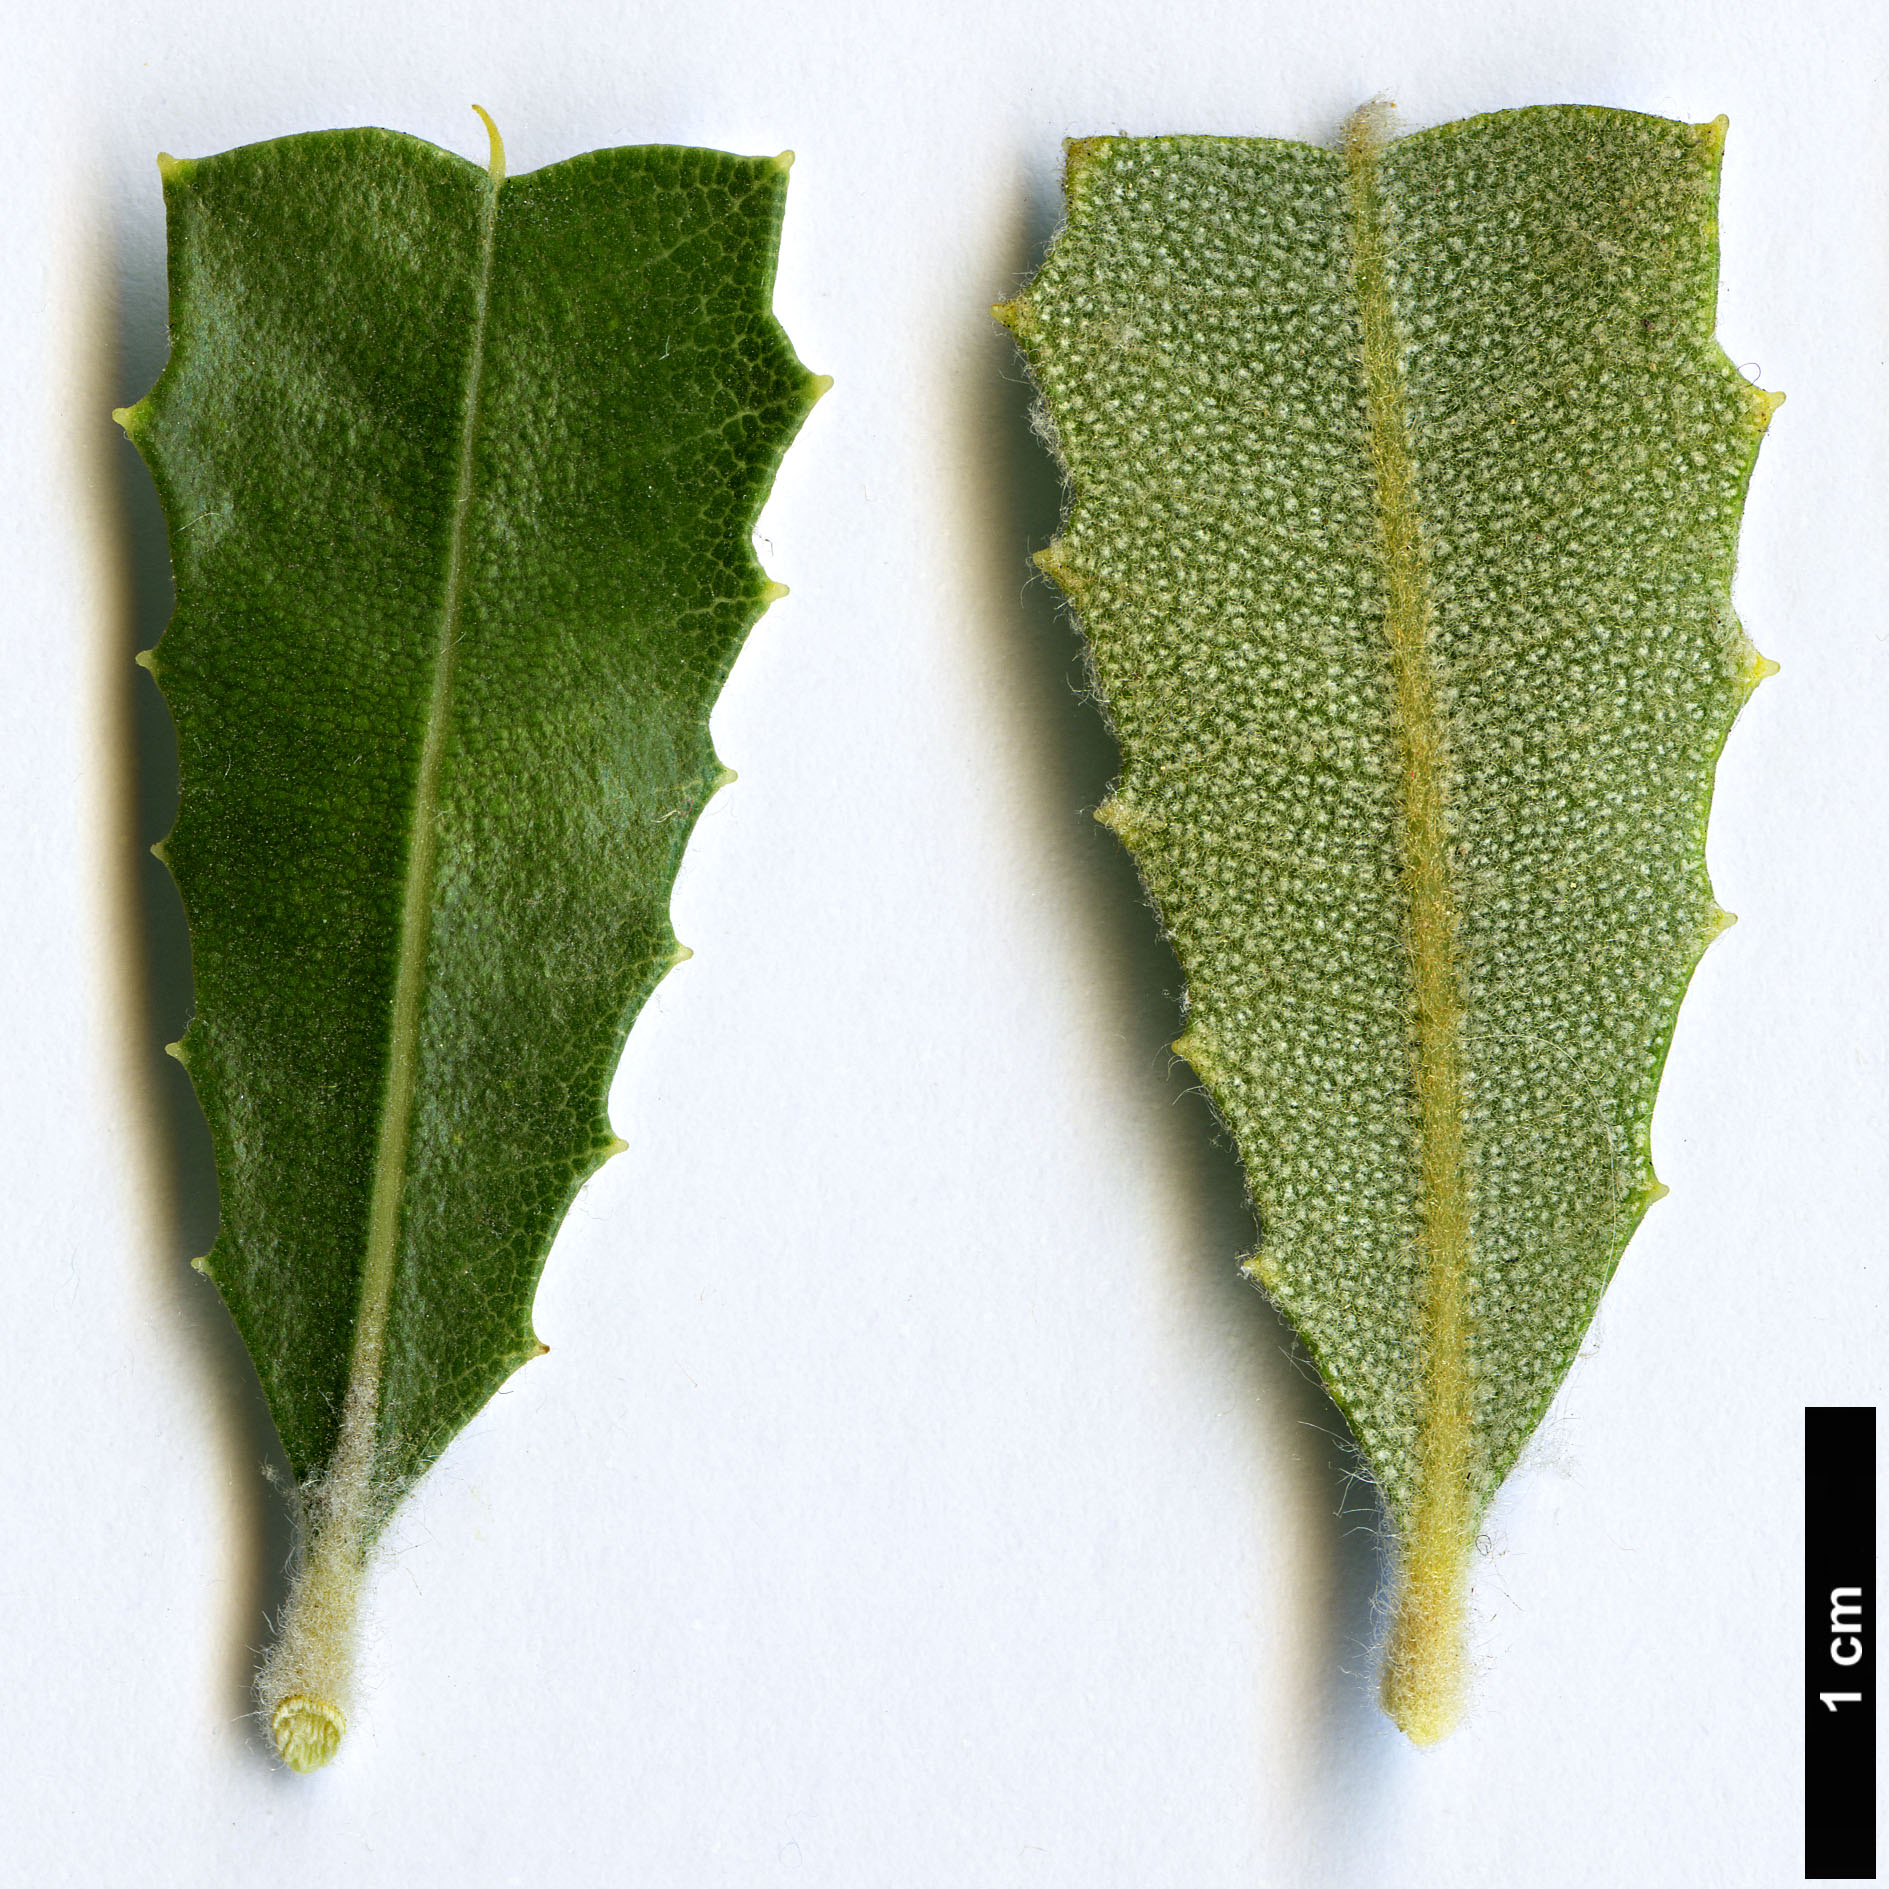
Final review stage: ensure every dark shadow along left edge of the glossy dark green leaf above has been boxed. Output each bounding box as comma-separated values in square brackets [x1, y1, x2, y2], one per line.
[101, 191, 293, 1749]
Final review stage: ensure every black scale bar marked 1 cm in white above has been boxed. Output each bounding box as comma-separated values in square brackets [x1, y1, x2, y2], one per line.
[1804, 1407, 1876, 1881]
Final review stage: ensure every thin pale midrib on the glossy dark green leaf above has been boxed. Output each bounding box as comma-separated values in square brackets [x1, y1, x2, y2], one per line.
[331, 162, 501, 1521]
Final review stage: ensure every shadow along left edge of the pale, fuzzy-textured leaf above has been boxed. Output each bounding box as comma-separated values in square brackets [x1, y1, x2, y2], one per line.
[965, 151, 1402, 1798]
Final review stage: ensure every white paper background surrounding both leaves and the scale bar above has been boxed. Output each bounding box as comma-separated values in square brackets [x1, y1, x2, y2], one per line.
[0, 0, 1889, 1889]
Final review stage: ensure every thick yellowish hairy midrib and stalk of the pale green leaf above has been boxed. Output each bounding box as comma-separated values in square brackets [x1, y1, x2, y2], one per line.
[1345, 113, 1473, 1736]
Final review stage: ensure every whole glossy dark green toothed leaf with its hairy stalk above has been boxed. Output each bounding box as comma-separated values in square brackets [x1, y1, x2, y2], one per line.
[125, 130, 824, 1762]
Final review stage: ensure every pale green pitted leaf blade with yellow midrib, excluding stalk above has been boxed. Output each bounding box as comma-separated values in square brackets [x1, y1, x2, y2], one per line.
[1005, 108, 1774, 1528]
